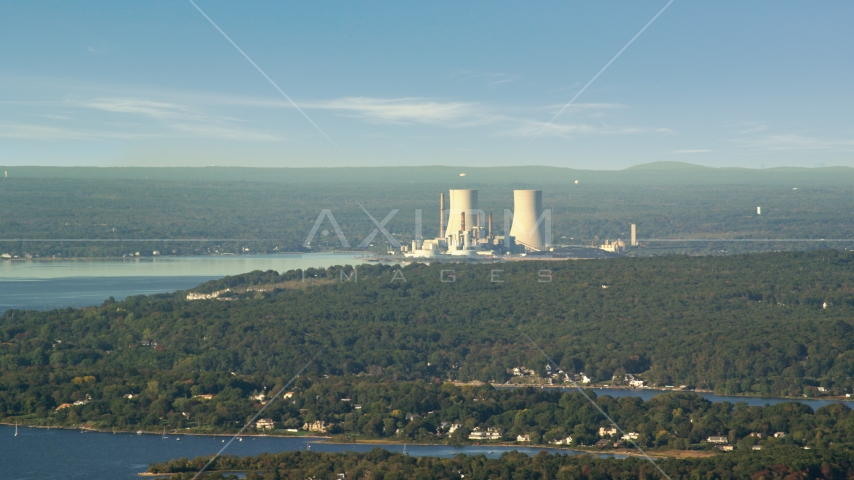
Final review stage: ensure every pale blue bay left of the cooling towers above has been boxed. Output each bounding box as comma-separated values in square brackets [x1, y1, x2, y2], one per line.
[0, 253, 365, 312]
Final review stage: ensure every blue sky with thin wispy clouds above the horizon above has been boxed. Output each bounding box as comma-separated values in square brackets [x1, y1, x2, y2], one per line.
[0, 0, 854, 169]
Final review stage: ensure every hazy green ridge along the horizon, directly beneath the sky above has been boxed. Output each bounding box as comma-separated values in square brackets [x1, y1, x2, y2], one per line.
[0, 162, 854, 188]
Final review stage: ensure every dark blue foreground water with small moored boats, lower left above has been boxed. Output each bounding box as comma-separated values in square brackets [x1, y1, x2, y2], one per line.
[0, 425, 604, 480]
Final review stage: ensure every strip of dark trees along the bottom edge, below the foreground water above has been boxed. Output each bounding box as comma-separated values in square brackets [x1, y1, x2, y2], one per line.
[149, 448, 854, 480]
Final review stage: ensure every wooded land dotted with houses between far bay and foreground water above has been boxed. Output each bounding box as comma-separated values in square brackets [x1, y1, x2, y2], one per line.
[0, 250, 854, 449]
